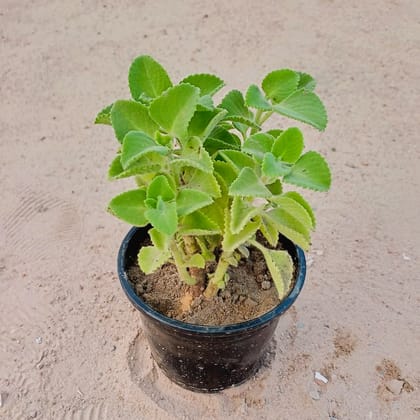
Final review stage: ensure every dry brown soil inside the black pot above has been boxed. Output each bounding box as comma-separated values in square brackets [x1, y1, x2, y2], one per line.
[128, 240, 293, 325]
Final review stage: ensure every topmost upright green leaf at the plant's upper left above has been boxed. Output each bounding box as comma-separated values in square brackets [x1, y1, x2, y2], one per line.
[128, 55, 172, 100]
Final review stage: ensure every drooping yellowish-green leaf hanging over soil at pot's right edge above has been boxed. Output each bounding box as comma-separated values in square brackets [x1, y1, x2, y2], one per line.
[251, 241, 294, 299]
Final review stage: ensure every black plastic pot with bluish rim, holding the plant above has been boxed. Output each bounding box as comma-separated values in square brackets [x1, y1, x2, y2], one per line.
[118, 228, 306, 392]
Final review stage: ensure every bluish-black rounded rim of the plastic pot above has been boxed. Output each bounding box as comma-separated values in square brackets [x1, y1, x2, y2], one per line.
[117, 227, 306, 334]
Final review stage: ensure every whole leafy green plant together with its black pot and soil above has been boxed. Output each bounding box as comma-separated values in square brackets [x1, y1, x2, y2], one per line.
[95, 56, 331, 391]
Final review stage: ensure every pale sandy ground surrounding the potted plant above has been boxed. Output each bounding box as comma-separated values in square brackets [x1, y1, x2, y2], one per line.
[0, 0, 420, 420]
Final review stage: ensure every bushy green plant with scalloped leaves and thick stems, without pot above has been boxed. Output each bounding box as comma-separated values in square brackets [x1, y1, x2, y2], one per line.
[95, 55, 331, 299]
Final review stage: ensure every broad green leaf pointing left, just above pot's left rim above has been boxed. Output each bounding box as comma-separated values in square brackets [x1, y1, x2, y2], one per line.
[108, 189, 148, 226]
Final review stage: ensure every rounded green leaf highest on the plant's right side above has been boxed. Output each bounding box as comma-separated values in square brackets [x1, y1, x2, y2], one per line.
[262, 69, 299, 103]
